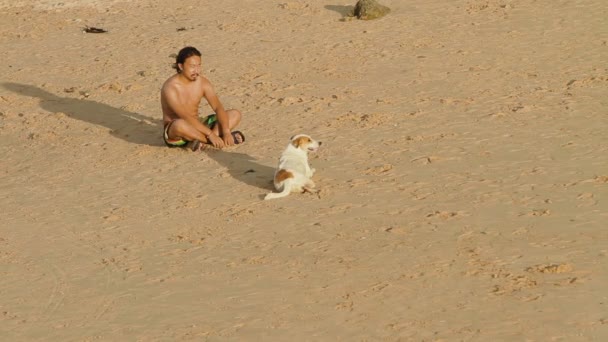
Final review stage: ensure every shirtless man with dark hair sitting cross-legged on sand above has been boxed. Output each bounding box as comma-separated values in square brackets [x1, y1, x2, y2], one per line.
[160, 46, 245, 151]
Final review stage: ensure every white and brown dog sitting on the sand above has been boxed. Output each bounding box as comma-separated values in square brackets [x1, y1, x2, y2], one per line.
[264, 134, 321, 200]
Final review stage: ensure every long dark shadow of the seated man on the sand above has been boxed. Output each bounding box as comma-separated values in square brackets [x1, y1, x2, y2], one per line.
[2, 82, 162, 146]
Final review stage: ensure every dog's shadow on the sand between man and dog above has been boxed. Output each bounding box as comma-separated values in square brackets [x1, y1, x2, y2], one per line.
[207, 150, 275, 198]
